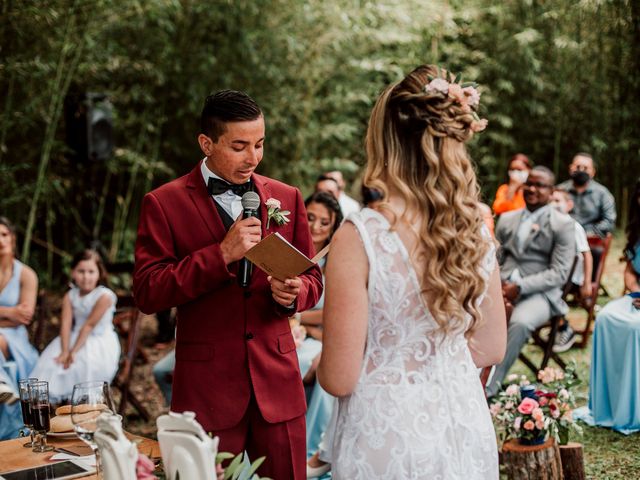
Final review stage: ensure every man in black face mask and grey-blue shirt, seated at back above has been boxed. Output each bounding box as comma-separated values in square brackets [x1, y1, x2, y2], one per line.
[558, 153, 616, 237]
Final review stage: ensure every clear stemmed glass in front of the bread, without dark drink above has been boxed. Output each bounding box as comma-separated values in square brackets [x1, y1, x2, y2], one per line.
[71, 382, 115, 478]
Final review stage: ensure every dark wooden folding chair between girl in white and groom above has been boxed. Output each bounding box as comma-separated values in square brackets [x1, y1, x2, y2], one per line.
[112, 296, 151, 422]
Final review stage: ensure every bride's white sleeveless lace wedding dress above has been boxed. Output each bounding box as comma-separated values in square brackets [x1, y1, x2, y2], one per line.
[332, 209, 498, 480]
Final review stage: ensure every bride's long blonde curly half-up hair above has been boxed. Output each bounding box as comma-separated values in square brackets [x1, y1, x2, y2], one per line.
[364, 65, 490, 334]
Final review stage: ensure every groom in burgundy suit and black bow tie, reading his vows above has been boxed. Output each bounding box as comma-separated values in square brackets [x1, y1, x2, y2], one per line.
[133, 90, 322, 480]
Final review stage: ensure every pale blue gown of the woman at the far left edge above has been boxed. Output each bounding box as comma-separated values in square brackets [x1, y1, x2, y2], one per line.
[0, 260, 38, 440]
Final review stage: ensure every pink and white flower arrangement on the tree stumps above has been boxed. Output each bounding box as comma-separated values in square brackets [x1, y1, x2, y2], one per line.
[489, 366, 582, 445]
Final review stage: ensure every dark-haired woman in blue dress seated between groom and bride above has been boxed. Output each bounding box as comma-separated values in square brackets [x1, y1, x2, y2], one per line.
[297, 192, 343, 464]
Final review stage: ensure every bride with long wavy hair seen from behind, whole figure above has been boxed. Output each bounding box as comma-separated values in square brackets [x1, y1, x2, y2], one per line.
[318, 66, 506, 480]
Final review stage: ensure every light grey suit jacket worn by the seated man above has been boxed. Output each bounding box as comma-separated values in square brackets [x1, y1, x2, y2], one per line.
[496, 208, 576, 315]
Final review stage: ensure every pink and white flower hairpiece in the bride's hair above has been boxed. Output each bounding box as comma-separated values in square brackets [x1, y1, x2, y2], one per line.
[424, 68, 489, 132]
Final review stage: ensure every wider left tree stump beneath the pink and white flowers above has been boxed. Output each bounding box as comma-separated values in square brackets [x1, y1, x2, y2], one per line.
[502, 438, 564, 480]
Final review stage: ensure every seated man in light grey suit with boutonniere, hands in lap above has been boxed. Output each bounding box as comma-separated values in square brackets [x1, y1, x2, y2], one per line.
[487, 167, 576, 396]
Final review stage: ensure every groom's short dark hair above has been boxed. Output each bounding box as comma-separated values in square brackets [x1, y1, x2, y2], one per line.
[200, 90, 262, 142]
